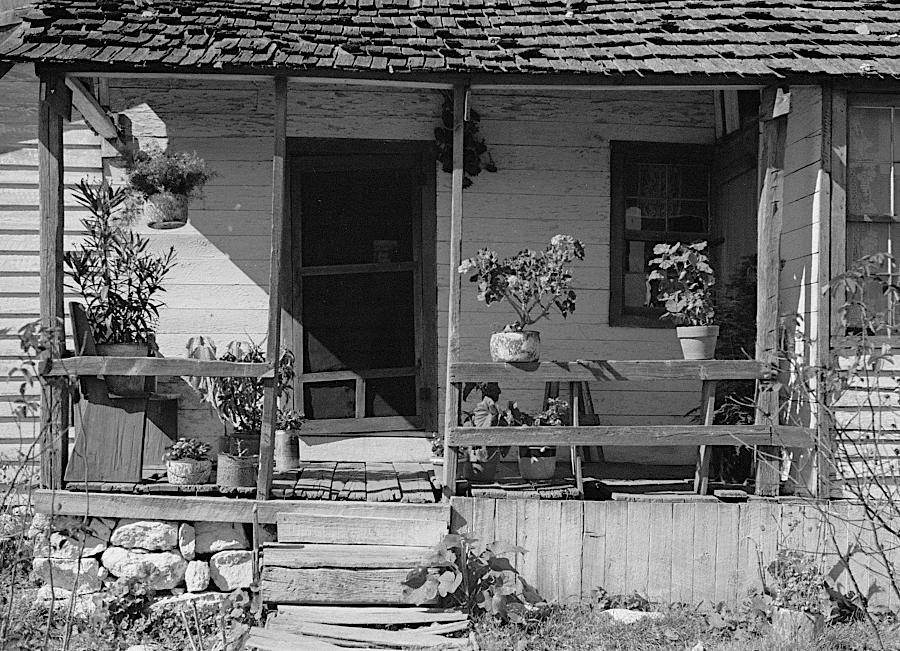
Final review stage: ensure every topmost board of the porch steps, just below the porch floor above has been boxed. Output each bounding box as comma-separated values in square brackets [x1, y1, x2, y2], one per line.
[277, 513, 448, 547]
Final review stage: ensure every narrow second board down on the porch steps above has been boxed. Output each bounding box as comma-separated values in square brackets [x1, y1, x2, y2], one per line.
[263, 544, 431, 569]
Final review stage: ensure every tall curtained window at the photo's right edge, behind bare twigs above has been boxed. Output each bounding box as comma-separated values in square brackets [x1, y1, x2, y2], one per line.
[847, 95, 900, 332]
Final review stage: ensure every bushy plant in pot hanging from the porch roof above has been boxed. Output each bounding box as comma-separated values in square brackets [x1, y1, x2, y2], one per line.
[125, 149, 211, 229]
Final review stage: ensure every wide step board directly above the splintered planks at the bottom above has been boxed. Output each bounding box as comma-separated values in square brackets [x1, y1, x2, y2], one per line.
[262, 567, 428, 605]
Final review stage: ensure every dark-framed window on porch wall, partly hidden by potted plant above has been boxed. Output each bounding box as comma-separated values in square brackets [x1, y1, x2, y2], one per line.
[609, 142, 712, 328]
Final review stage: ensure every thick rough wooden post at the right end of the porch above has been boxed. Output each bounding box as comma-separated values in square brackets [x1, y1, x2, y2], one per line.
[756, 88, 787, 496]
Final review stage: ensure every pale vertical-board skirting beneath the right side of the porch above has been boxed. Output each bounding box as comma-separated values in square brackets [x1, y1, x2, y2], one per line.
[451, 497, 900, 610]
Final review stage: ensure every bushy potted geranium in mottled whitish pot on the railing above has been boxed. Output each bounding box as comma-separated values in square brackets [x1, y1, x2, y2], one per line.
[459, 235, 584, 362]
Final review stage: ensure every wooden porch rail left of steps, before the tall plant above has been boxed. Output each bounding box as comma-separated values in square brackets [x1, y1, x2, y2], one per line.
[40, 356, 275, 379]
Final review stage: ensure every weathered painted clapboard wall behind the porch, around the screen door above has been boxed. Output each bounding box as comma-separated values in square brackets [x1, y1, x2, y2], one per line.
[102, 80, 714, 462]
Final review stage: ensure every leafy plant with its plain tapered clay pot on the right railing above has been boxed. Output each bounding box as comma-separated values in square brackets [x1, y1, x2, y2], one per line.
[648, 242, 719, 359]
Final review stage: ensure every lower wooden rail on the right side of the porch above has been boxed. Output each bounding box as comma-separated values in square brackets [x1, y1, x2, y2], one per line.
[447, 425, 815, 447]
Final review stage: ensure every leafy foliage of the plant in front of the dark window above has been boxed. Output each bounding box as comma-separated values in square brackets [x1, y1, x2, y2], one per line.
[648, 242, 716, 326]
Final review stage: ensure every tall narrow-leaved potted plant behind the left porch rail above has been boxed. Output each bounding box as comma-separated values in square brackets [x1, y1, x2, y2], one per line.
[63, 181, 175, 396]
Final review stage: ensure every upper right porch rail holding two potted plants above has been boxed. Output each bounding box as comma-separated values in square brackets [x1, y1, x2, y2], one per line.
[449, 359, 775, 382]
